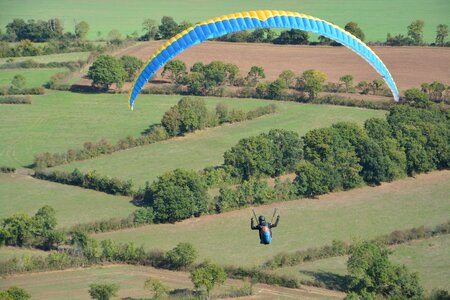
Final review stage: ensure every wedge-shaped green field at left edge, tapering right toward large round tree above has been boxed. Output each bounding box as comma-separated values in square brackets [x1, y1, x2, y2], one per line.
[0, 174, 136, 227]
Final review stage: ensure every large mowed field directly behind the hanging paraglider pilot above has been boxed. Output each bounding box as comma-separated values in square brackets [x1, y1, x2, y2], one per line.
[95, 171, 450, 266]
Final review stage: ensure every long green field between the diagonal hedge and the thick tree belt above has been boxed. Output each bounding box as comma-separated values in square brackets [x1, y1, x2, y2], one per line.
[51, 98, 386, 186]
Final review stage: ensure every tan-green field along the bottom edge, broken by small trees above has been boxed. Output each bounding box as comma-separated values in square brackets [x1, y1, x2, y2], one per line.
[0, 265, 338, 300]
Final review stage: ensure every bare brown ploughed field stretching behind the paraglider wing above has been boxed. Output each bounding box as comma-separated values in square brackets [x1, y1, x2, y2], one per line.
[120, 41, 450, 90]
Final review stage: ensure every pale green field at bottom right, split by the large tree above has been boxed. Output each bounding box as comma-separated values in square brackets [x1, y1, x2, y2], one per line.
[273, 235, 450, 291]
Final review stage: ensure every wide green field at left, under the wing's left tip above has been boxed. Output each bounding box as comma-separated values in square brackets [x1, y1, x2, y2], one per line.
[0, 91, 181, 167]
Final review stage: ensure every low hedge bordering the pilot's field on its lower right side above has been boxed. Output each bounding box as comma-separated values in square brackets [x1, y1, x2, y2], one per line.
[263, 221, 450, 269]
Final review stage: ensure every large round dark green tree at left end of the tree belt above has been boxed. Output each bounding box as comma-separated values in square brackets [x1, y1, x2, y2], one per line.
[144, 169, 208, 222]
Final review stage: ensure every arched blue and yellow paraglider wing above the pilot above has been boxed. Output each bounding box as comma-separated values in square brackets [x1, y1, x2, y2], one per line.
[128, 10, 399, 109]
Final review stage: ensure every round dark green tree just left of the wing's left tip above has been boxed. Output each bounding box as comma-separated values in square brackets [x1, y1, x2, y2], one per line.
[87, 55, 128, 89]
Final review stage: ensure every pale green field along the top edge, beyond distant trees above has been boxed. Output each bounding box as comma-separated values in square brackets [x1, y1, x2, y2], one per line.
[0, 0, 450, 42]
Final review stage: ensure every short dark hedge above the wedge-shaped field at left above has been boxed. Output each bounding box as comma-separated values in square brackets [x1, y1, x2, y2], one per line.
[34, 169, 133, 196]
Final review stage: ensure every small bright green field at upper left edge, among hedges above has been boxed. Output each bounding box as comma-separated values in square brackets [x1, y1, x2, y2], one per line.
[0, 68, 67, 88]
